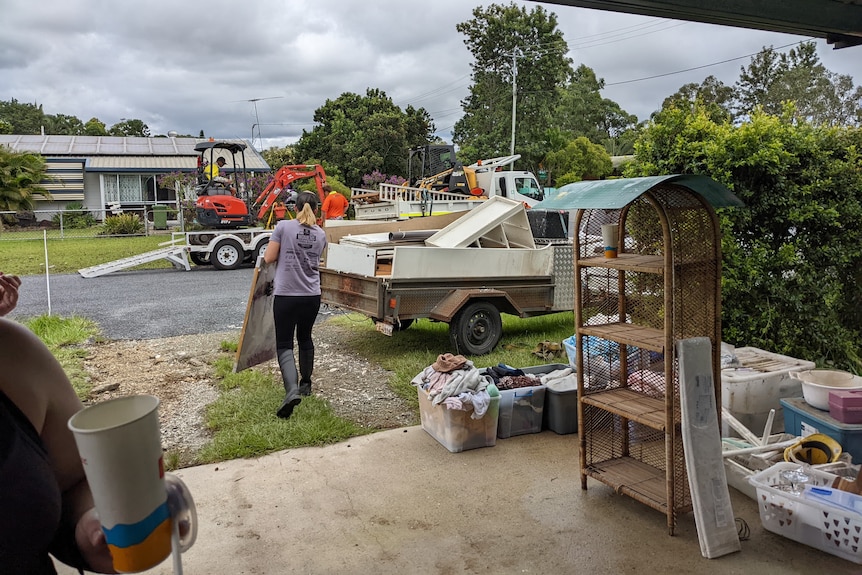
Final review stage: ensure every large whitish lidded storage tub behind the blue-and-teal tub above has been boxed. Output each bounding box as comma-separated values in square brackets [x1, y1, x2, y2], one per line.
[721, 347, 815, 437]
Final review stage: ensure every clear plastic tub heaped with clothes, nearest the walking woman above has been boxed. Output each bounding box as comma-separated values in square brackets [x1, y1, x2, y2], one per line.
[416, 387, 500, 453]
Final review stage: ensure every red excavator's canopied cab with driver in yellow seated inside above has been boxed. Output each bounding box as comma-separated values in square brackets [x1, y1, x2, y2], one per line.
[195, 140, 254, 228]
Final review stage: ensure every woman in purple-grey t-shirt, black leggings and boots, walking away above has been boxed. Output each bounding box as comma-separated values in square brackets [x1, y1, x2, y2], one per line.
[263, 192, 326, 419]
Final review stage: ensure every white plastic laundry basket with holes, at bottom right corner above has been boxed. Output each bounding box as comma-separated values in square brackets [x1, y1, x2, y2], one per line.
[749, 462, 862, 564]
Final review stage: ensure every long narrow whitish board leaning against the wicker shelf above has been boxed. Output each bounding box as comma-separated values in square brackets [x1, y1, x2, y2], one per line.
[677, 337, 742, 559]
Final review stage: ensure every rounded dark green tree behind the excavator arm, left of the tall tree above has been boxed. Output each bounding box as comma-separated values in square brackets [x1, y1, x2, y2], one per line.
[294, 88, 434, 186]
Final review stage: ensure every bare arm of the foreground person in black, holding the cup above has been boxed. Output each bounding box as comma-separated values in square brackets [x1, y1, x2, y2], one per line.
[0, 319, 114, 573]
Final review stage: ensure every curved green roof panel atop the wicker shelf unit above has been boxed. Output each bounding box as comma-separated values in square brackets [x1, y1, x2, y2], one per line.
[533, 174, 745, 210]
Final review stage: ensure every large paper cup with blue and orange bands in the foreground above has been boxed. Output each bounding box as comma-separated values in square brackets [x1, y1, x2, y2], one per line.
[69, 395, 171, 573]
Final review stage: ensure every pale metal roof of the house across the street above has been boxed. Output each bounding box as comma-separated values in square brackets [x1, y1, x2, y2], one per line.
[0, 134, 270, 171]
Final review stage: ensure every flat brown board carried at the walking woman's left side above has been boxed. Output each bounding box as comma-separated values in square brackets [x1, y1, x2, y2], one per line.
[233, 258, 276, 373]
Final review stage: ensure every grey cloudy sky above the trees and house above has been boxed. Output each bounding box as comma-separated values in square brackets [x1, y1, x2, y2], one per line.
[0, 0, 862, 148]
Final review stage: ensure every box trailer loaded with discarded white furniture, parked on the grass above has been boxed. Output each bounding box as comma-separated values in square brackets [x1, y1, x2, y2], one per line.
[320, 197, 574, 355]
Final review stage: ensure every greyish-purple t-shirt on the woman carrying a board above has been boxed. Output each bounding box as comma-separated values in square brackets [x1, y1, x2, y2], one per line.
[269, 220, 326, 296]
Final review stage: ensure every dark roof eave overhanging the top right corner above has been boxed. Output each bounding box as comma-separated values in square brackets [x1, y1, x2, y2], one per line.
[547, 0, 862, 48]
